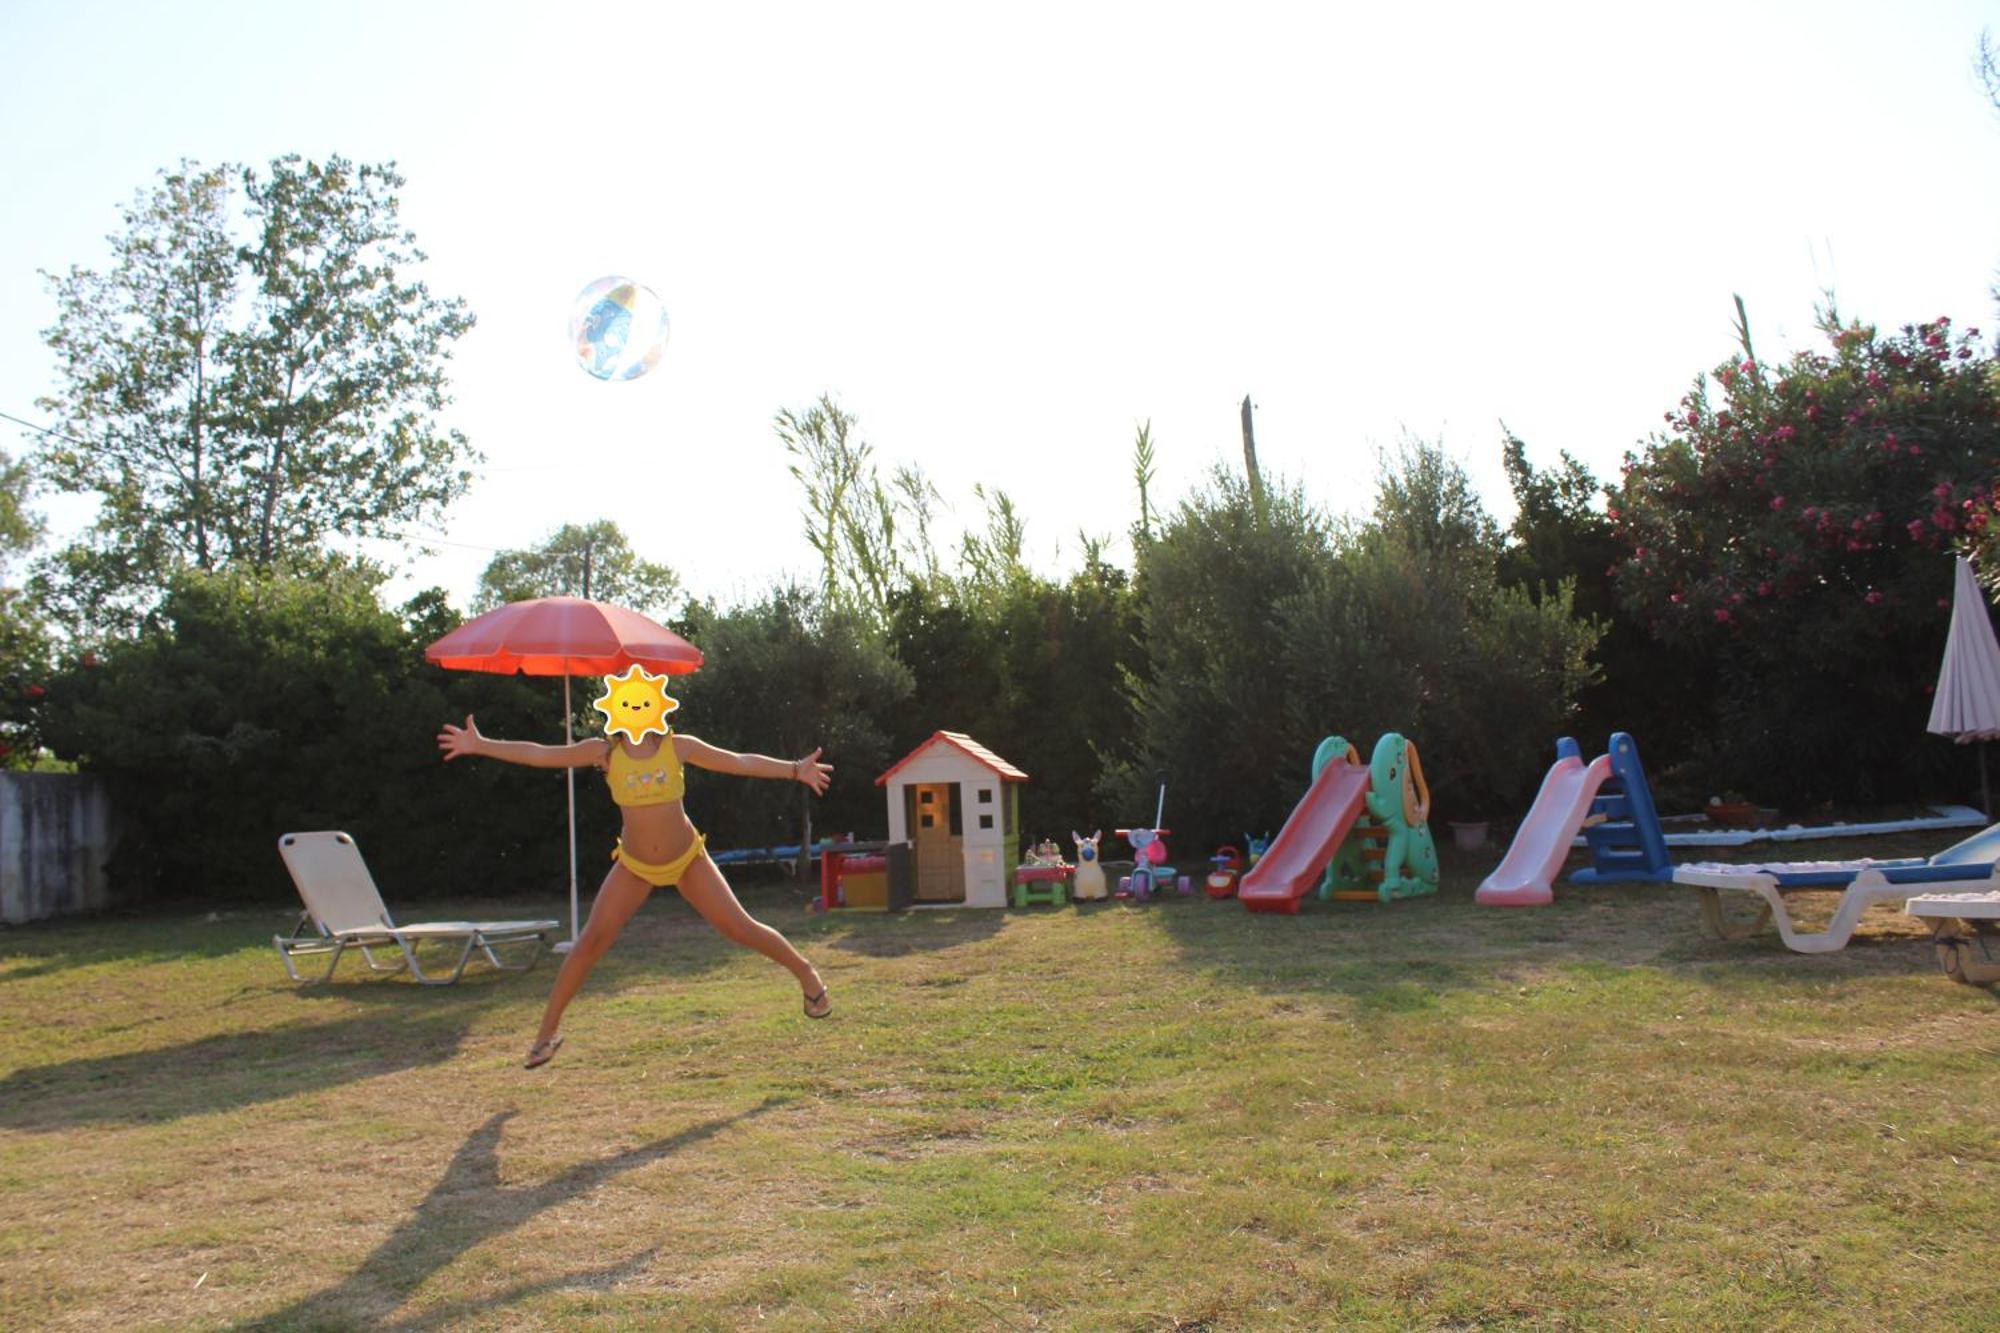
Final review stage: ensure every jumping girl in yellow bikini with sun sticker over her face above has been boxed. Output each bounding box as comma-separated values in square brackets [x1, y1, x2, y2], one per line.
[438, 667, 834, 1069]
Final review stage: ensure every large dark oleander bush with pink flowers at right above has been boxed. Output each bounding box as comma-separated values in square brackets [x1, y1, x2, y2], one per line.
[1612, 310, 2000, 801]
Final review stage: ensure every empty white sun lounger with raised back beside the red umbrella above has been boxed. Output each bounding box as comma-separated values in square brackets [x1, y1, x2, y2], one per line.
[272, 833, 560, 987]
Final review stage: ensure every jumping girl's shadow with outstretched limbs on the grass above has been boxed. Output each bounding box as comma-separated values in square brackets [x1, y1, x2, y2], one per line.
[236, 1097, 786, 1329]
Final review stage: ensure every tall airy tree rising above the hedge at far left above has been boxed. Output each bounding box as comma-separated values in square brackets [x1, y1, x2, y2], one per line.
[40, 154, 474, 628]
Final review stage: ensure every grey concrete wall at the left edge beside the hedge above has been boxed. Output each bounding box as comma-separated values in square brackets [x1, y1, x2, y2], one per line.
[0, 773, 114, 925]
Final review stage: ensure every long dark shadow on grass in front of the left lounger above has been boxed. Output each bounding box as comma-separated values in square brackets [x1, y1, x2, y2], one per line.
[0, 1008, 472, 1131]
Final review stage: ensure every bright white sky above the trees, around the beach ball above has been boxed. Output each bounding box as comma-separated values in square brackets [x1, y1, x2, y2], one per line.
[0, 0, 2000, 608]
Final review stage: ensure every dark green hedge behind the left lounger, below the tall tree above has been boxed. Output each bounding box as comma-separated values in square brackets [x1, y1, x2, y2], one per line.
[36, 562, 564, 903]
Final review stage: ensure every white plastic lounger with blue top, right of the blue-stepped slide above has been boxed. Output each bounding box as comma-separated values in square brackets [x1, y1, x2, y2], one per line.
[1674, 844, 2000, 953]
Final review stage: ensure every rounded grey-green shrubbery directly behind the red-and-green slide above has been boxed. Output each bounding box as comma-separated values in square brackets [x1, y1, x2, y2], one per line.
[1106, 442, 1598, 841]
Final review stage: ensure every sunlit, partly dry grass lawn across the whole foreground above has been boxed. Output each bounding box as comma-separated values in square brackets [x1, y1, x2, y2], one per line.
[0, 835, 2000, 1333]
